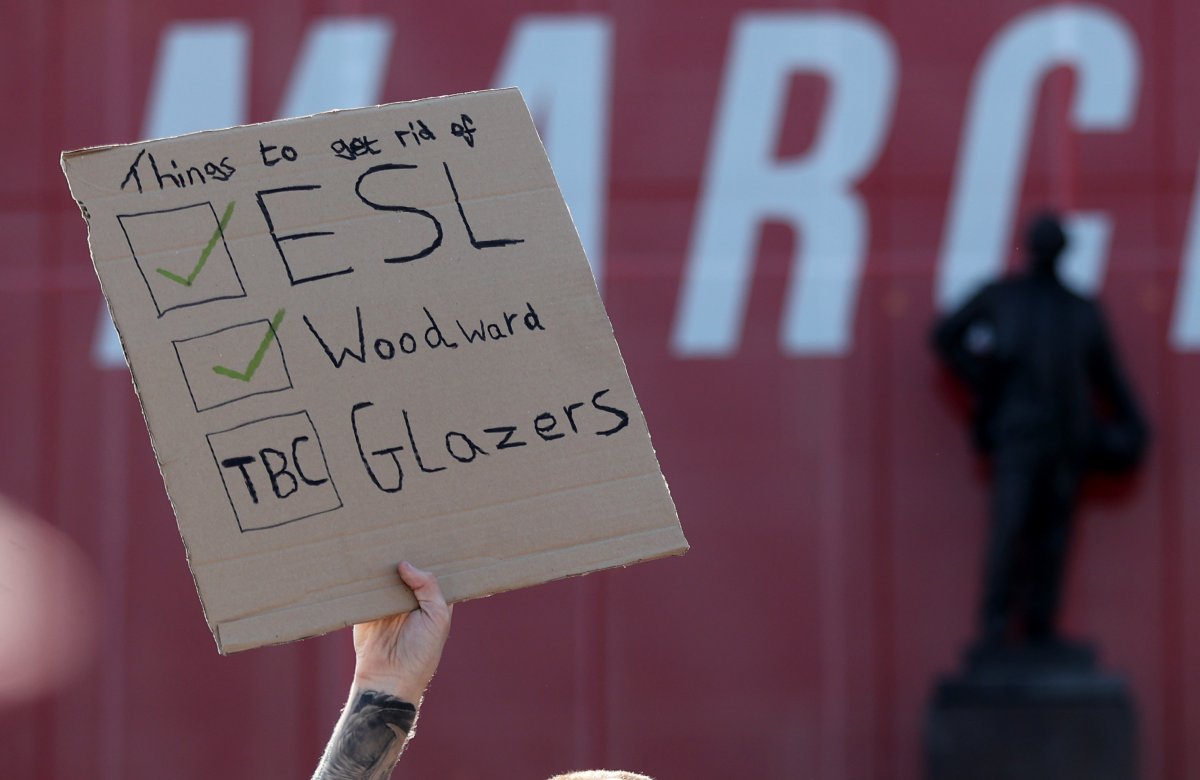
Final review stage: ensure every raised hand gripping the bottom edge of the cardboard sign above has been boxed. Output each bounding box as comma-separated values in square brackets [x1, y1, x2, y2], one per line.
[354, 560, 452, 704]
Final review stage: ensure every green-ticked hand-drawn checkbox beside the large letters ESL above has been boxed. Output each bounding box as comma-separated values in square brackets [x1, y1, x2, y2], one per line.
[116, 200, 246, 317]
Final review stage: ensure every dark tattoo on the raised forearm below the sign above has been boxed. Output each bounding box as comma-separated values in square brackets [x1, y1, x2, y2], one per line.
[313, 690, 416, 780]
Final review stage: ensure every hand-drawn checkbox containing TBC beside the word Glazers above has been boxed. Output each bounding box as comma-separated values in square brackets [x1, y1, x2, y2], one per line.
[208, 410, 342, 533]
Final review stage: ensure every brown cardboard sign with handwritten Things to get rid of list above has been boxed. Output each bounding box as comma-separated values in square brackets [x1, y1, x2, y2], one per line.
[62, 89, 688, 653]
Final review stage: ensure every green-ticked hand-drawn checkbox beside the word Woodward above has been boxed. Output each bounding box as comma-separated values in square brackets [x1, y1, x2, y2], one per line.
[170, 310, 292, 412]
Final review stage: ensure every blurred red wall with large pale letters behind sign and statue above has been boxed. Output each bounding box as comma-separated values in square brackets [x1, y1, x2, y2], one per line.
[0, 0, 1200, 780]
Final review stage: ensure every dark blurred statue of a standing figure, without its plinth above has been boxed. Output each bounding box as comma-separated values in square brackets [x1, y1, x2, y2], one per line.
[932, 214, 1148, 647]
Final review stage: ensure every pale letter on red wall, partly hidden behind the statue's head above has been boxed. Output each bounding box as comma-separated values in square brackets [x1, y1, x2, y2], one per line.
[937, 6, 1140, 307]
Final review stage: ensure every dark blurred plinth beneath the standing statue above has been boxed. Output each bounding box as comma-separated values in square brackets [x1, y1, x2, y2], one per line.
[925, 642, 1138, 780]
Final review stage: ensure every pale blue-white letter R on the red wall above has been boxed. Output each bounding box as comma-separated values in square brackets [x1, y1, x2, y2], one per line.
[672, 12, 896, 356]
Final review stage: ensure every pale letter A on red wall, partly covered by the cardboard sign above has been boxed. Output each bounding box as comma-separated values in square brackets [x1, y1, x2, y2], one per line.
[494, 14, 612, 289]
